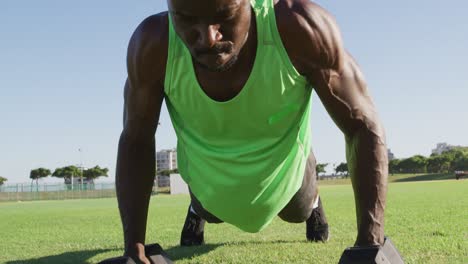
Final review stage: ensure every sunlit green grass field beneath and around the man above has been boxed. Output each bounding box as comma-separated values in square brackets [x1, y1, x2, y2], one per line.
[0, 180, 468, 264]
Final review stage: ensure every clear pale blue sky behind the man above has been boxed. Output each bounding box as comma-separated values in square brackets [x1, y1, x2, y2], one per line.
[0, 0, 468, 184]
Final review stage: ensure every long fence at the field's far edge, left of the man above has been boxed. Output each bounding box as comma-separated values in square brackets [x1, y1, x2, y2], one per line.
[0, 183, 158, 202]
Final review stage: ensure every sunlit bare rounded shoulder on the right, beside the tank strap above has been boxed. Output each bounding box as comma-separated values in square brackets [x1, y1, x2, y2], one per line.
[275, 0, 345, 75]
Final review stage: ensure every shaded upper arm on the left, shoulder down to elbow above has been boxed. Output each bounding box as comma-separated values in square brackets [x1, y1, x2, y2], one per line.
[124, 13, 169, 135]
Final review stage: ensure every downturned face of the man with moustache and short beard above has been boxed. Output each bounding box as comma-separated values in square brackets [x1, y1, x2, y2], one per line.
[168, 0, 251, 71]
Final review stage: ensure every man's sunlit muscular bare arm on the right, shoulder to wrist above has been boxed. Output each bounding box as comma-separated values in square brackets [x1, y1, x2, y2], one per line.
[275, 0, 388, 246]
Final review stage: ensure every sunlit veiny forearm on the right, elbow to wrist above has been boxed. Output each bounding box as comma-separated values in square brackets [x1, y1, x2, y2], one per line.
[346, 126, 388, 246]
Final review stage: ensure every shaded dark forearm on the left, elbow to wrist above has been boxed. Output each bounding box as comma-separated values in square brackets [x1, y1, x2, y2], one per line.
[116, 133, 155, 255]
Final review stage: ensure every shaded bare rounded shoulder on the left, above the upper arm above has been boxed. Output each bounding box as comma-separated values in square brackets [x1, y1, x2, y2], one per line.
[127, 12, 169, 86]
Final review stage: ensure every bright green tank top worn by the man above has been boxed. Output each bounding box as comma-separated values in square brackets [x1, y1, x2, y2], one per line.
[164, 0, 312, 232]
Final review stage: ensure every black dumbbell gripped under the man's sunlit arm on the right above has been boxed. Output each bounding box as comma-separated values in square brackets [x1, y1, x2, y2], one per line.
[339, 237, 404, 264]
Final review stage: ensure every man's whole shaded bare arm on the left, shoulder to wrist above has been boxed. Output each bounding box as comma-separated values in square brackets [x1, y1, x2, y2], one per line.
[116, 14, 167, 258]
